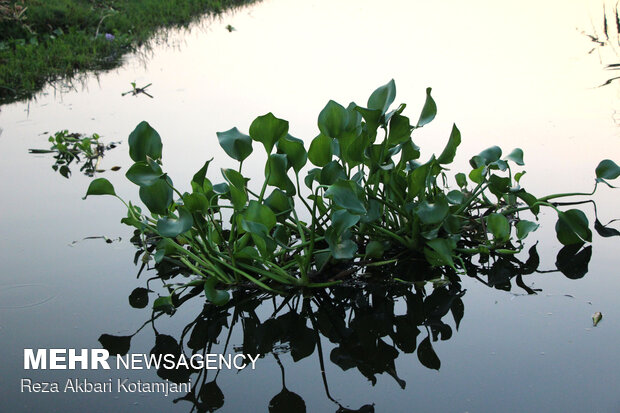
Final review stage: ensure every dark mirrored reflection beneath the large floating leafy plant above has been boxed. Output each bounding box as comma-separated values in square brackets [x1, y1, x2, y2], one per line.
[99, 233, 592, 412]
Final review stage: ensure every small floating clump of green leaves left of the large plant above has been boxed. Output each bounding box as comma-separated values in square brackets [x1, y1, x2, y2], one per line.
[28, 130, 119, 178]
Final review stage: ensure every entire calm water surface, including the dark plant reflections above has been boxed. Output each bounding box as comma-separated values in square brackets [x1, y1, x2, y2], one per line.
[0, 1, 620, 412]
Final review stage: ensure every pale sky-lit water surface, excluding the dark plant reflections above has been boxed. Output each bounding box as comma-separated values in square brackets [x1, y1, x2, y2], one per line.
[0, 0, 620, 411]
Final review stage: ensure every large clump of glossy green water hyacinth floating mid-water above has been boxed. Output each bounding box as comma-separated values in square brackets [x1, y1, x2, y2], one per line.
[86, 81, 620, 308]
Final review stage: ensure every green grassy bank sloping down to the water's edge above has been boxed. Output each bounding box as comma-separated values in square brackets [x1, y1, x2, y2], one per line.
[0, 0, 252, 104]
